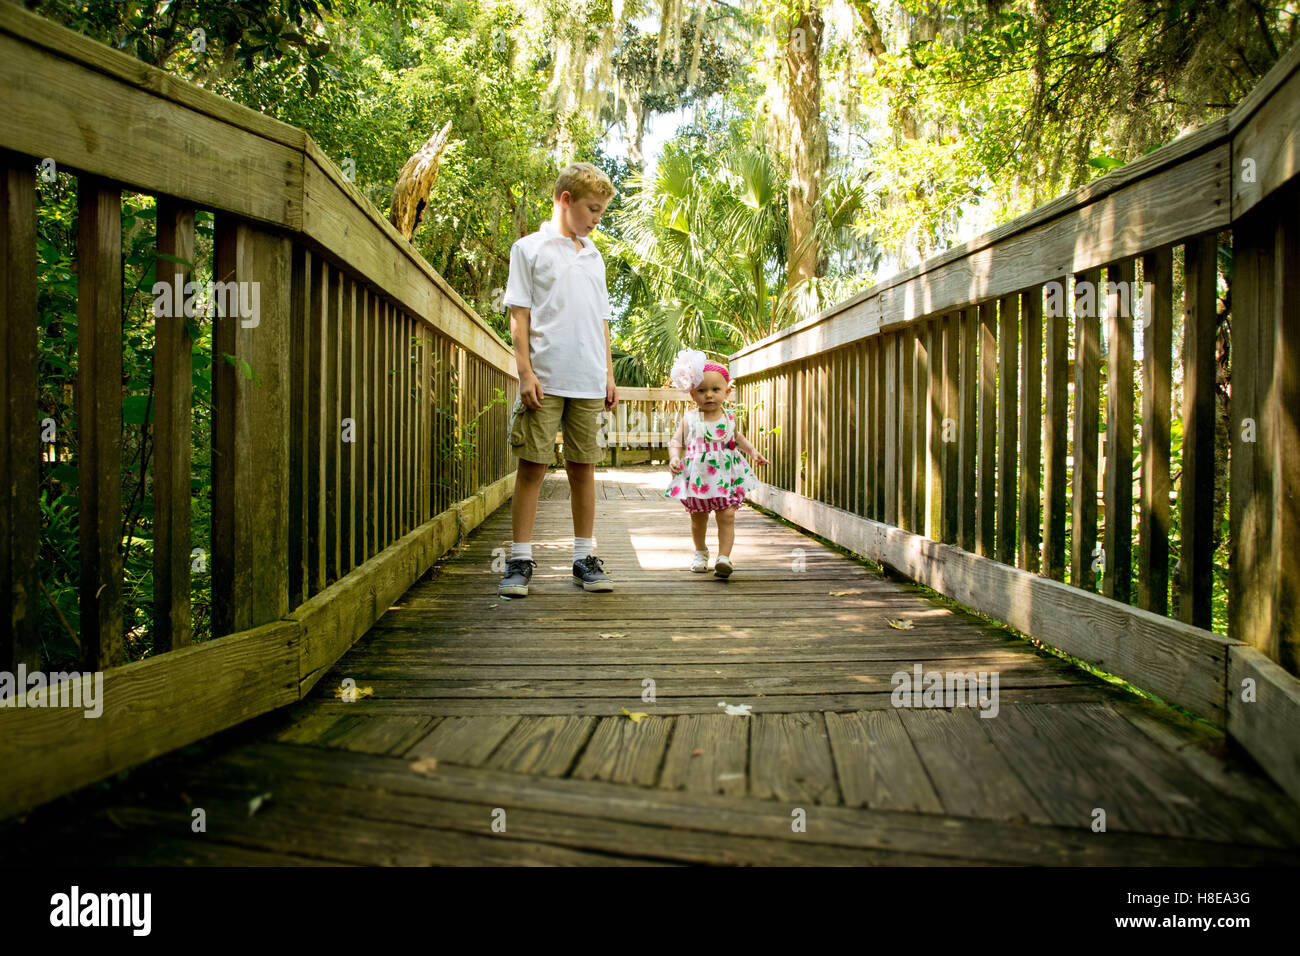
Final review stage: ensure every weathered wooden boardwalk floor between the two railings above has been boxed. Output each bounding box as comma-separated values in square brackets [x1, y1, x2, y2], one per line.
[0, 468, 1300, 865]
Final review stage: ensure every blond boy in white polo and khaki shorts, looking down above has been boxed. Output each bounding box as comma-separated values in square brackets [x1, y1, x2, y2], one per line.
[498, 163, 618, 597]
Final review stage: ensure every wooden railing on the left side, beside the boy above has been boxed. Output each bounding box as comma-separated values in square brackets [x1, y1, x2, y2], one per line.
[0, 4, 516, 817]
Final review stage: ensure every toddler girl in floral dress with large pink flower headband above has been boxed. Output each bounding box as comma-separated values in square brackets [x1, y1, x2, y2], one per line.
[664, 349, 768, 578]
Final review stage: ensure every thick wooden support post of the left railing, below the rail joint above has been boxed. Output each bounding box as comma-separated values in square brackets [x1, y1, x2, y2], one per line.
[212, 215, 291, 636]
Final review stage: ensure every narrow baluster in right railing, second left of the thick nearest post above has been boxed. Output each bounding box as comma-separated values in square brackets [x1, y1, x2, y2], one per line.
[1138, 246, 1175, 614]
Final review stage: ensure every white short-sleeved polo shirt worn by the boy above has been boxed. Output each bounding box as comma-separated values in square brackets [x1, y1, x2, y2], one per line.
[502, 220, 612, 398]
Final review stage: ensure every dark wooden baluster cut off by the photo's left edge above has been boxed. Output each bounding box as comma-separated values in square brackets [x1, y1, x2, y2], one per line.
[0, 153, 39, 672]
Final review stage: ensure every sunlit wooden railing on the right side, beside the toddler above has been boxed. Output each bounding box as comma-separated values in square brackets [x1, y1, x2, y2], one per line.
[732, 49, 1300, 796]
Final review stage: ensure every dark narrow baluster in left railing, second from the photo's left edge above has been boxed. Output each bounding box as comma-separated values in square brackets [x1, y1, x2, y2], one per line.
[77, 176, 124, 670]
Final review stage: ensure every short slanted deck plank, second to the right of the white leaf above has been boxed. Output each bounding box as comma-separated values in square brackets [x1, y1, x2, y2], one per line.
[824, 710, 944, 813]
